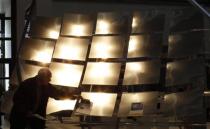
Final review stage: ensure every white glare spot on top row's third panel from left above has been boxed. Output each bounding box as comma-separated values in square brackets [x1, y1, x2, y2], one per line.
[96, 20, 110, 34]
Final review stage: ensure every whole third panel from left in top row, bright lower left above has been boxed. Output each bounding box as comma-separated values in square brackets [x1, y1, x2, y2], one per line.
[96, 13, 127, 34]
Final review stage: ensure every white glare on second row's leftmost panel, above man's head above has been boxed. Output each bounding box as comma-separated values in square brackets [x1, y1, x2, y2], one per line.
[32, 49, 52, 63]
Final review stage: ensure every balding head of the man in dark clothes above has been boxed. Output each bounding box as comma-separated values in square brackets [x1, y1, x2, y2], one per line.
[37, 68, 52, 85]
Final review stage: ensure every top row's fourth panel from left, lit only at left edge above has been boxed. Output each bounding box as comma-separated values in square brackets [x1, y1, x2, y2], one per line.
[132, 10, 165, 33]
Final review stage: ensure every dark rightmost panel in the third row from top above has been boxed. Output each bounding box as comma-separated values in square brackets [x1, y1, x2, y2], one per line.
[166, 60, 204, 86]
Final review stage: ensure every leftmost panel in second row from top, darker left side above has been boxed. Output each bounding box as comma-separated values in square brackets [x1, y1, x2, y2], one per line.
[20, 39, 55, 63]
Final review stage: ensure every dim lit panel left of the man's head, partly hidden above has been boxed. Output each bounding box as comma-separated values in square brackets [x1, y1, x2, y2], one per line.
[20, 62, 42, 80]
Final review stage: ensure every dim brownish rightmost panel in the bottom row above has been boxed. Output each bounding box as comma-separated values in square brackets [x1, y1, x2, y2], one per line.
[161, 85, 203, 116]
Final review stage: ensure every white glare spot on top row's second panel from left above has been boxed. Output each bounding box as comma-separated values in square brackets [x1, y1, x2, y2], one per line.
[70, 25, 85, 36]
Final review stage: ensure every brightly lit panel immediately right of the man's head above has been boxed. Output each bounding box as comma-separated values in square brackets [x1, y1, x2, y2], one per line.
[50, 62, 83, 87]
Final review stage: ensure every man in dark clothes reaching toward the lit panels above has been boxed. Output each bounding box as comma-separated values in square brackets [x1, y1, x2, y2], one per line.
[10, 68, 79, 129]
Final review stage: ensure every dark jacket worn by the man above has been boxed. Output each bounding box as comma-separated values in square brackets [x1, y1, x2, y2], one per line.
[12, 77, 63, 117]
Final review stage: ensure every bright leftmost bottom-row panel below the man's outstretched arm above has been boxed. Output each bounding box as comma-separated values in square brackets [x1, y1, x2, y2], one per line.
[47, 98, 76, 114]
